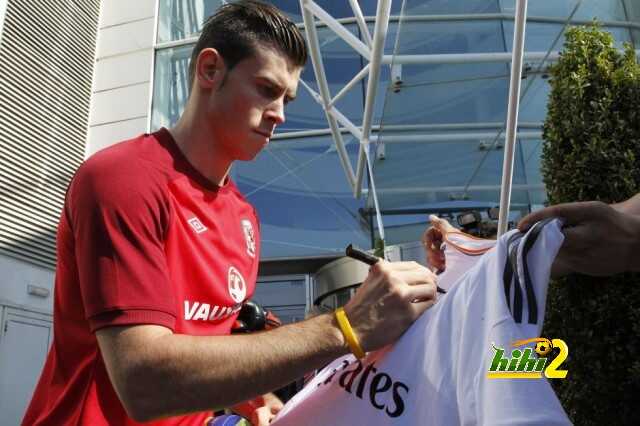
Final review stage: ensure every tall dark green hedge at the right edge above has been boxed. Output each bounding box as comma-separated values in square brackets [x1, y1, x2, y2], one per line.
[542, 24, 640, 425]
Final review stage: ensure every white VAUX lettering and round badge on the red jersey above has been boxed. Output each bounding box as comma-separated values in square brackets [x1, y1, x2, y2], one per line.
[184, 266, 247, 321]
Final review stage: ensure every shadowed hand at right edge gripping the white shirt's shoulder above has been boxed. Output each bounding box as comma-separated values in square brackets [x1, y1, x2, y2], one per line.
[518, 201, 640, 277]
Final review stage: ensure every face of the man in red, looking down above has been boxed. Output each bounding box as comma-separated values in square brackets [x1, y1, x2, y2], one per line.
[207, 46, 302, 161]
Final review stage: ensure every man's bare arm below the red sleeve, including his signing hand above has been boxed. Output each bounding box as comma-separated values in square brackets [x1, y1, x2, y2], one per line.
[96, 260, 437, 421]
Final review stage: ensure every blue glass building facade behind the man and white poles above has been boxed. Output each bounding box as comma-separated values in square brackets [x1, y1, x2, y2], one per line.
[151, 0, 640, 262]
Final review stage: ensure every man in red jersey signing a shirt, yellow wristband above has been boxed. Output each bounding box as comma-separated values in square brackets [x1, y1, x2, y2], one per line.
[23, 1, 436, 426]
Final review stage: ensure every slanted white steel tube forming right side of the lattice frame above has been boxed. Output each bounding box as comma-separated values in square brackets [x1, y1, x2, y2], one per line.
[354, 0, 391, 198]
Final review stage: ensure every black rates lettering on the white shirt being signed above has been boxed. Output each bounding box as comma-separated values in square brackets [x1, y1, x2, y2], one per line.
[318, 360, 409, 418]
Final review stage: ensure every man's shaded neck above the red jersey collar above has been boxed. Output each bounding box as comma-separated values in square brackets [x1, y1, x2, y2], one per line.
[169, 112, 232, 186]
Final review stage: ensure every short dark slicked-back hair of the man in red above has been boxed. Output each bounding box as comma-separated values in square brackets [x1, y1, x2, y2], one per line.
[189, 0, 307, 87]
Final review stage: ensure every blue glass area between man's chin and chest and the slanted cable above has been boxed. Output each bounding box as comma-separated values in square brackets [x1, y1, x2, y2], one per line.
[234, 135, 370, 258]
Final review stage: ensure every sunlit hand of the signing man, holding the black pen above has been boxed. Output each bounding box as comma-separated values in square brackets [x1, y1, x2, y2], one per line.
[344, 260, 437, 351]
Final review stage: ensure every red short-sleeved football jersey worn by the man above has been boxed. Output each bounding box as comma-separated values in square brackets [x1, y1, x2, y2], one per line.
[23, 129, 260, 426]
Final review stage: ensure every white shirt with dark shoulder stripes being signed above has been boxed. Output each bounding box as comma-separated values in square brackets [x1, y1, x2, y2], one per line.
[274, 221, 569, 426]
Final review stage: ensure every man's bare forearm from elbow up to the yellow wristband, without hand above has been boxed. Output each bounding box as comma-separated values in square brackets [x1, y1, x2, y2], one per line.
[112, 315, 347, 419]
